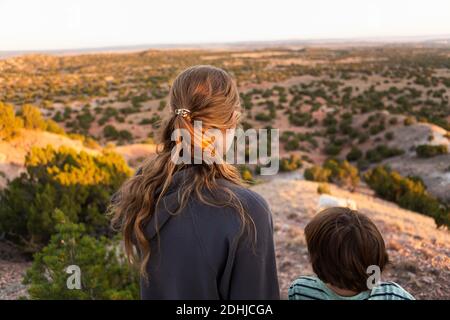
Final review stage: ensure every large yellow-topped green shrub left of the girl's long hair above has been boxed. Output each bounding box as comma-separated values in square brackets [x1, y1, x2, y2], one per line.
[0, 146, 131, 251]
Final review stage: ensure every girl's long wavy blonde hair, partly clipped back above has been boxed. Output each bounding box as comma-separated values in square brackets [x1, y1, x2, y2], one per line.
[109, 65, 256, 276]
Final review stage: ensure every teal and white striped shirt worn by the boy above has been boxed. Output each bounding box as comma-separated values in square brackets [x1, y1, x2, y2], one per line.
[288, 277, 415, 300]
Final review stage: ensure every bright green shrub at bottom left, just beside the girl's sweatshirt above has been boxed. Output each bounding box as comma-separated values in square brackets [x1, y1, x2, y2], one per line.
[24, 209, 139, 300]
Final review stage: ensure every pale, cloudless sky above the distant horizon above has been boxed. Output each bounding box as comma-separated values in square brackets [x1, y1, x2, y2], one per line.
[0, 0, 450, 51]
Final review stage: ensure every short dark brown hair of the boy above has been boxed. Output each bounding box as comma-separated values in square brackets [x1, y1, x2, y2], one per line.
[305, 207, 389, 292]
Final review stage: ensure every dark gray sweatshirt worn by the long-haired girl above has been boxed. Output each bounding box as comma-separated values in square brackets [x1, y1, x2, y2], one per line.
[141, 169, 279, 299]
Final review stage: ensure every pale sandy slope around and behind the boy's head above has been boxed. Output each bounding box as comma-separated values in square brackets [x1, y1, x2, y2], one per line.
[253, 179, 450, 299]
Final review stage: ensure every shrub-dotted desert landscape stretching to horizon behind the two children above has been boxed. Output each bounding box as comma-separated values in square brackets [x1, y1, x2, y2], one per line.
[0, 44, 450, 299]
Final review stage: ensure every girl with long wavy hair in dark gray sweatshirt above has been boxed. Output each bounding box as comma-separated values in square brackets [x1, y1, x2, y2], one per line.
[111, 66, 279, 299]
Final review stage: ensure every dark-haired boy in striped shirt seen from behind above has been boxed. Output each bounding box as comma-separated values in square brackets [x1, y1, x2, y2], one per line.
[288, 207, 414, 300]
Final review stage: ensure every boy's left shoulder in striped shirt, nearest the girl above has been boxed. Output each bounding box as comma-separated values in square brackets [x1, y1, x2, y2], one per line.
[288, 276, 328, 300]
